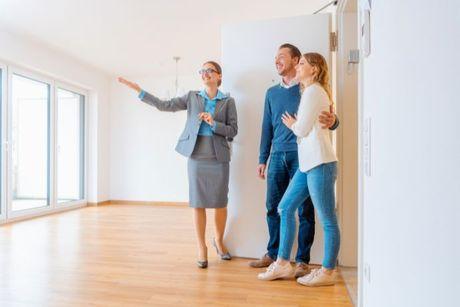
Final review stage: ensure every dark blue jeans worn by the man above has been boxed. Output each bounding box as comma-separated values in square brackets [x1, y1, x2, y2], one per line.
[266, 151, 315, 263]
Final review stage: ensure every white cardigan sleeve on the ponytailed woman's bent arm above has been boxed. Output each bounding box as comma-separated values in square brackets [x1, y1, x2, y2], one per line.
[291, 85, 322, 138]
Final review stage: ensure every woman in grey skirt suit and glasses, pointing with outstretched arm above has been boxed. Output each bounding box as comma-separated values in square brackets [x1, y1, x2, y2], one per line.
[118, 61, 238, 268]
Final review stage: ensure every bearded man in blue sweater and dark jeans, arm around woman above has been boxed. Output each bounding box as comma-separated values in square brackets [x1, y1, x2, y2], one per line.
[249, 44, 338, 278]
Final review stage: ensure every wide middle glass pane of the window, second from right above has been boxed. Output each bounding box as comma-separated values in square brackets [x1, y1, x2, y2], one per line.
[11, 75, 50, 211]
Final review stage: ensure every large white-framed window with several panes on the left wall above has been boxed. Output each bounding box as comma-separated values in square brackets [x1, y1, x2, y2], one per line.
[0, 63, 87, 221]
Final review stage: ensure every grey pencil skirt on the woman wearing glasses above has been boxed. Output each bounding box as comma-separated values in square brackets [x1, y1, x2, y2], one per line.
[187, 137, 229, 208]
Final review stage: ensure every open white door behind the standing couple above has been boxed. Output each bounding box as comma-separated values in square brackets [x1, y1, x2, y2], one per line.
[222, 14, 331, 263]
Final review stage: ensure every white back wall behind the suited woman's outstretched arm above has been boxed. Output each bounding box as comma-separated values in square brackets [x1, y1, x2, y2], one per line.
[110, 74, 201, 202]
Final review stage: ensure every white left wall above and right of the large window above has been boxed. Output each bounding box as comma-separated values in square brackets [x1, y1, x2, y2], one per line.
[0, 28, 109, 202]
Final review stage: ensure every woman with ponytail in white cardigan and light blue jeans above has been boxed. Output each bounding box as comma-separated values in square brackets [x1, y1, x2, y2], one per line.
[258, 53, 340, 286]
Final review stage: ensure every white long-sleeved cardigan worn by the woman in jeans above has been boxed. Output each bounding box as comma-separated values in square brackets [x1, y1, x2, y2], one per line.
[291, 83, 337, 172]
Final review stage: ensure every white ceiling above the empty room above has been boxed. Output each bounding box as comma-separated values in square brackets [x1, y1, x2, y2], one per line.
[0, 0, 329, 76]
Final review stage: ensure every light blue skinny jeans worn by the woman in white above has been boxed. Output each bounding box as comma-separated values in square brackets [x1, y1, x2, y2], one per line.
[278, 162, 340, 269]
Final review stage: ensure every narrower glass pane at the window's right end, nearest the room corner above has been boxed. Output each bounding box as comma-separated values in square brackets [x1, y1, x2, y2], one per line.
[57, 89, 84, 203]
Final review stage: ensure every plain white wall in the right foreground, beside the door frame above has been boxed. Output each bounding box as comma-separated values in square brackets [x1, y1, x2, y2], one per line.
[361, 0, 460, 307]
